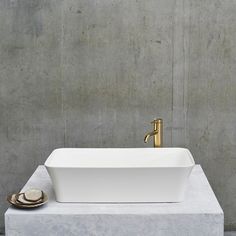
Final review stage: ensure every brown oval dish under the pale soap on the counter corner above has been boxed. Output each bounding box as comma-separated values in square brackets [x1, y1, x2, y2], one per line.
[7, 190, 48, 209]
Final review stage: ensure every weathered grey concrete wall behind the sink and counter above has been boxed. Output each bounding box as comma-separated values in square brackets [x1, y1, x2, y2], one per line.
[0, 0, 236, 232]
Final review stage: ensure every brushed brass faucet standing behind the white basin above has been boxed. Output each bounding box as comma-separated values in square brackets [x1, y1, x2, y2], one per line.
[144, 118, 163, 148]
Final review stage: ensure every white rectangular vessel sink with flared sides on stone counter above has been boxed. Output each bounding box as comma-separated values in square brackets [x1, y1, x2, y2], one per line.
[45, 148, 195, 202]
